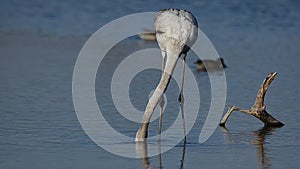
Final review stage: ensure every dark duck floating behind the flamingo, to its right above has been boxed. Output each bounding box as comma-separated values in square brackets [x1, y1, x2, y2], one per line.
[194, 58, 227, 72]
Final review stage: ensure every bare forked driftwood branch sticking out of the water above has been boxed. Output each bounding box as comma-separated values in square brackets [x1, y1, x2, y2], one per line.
[219, 72, 284, 127]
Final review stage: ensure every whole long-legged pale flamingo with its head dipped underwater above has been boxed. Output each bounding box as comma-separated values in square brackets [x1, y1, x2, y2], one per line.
[135, 9, 198, 141]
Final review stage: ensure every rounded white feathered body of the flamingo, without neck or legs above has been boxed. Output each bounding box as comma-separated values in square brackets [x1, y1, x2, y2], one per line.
[154, 9, 198, 53]
